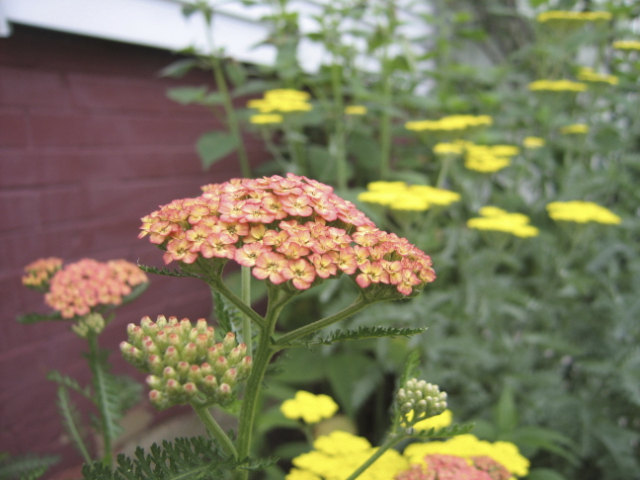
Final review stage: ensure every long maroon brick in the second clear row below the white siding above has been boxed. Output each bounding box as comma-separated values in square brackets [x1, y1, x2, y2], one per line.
[30, 113, 213, 147]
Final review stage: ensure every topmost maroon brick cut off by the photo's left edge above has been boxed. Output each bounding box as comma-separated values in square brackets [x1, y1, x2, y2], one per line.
[0, 67, 67, 107]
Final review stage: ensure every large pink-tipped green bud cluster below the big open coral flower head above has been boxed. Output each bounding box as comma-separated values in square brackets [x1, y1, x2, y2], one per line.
[120, 315, 252, 409]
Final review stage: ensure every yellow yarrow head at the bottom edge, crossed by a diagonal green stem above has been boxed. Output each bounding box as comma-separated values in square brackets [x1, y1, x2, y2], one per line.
[285, 430, 409, 480]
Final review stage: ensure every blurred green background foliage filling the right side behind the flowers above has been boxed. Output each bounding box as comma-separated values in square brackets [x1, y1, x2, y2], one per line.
[165, 0, 640, 480]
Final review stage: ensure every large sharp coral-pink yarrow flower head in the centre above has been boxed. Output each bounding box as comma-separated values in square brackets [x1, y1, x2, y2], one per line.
[140, 174, 435, 295]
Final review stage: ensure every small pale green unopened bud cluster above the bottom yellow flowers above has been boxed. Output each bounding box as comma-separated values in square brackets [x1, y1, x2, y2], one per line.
[397, 378, 447, 426]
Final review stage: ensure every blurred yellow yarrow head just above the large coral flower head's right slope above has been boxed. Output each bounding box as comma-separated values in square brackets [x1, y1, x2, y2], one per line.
[358, 182, 460, 211]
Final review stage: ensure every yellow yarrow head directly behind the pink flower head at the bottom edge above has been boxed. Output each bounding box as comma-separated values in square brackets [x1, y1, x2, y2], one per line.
[403, 434, 529, 477]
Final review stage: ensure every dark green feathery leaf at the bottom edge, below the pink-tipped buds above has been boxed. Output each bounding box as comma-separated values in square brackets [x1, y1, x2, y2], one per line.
[82, 437, 275, 480]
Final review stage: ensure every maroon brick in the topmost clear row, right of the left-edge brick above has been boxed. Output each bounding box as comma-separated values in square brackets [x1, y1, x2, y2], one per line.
[68, 74, 211, 115]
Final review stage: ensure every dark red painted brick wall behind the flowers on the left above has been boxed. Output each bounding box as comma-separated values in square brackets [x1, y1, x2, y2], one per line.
[0, 26, 266, 469]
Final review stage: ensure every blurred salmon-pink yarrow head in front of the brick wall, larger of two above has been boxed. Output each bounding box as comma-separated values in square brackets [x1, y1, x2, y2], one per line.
[45, 258, 148, 318]
